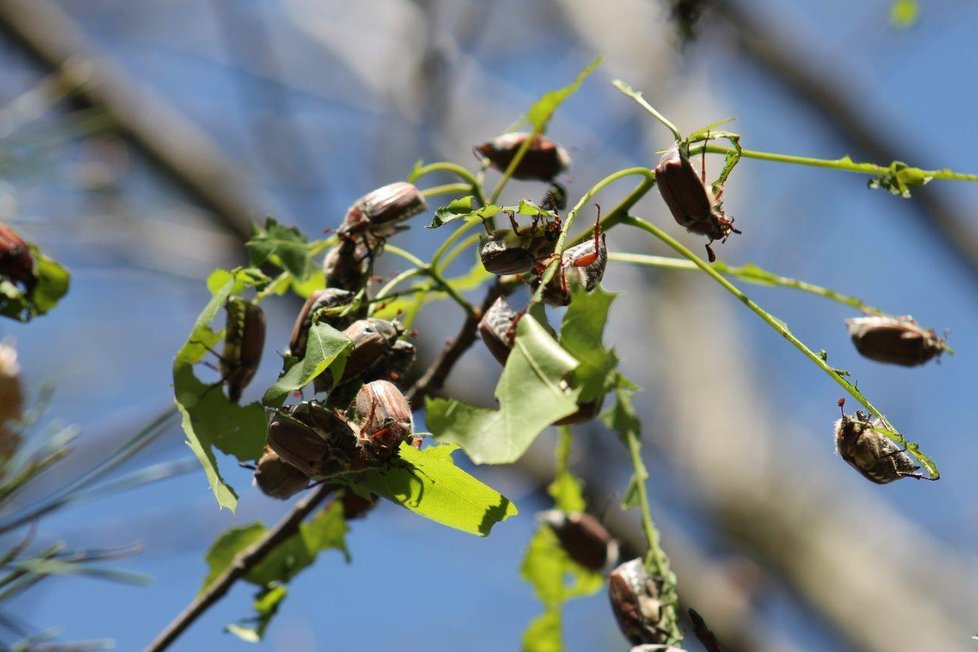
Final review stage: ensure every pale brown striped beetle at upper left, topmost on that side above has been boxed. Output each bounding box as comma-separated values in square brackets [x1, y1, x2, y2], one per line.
[337, 181, 428, 244]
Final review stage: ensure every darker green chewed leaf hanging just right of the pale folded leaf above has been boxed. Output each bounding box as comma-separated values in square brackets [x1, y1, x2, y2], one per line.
[560, 286, 618, 402]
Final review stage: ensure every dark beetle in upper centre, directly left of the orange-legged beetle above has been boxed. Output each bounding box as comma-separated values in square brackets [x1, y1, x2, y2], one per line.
[479, 213, 560, 276]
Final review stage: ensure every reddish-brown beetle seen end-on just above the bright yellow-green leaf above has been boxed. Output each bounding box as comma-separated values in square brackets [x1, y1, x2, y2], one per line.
[356, 380, 414, 464]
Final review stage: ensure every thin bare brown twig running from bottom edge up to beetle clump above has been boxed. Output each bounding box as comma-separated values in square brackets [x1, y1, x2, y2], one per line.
[146, 485, 336, 652]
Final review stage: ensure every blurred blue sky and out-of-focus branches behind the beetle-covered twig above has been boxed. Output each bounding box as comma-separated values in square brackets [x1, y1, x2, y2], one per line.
[0, 0, 978, 651]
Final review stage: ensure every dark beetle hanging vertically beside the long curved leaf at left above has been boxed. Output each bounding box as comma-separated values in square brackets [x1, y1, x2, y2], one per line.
[220, 296, 265, 402]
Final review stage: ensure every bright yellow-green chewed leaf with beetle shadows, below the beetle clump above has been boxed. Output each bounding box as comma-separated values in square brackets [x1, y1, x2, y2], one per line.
[351, 443, 517, 536]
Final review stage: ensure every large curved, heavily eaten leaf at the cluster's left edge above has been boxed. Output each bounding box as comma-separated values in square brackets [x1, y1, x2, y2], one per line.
[173, 269, 266, 512]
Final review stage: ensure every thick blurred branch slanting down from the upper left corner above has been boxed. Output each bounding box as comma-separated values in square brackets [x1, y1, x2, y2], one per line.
[0, 0, 257, 238]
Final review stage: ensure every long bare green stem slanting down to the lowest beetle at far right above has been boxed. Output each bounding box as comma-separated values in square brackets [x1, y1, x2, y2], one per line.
[623, 216, 940, 480]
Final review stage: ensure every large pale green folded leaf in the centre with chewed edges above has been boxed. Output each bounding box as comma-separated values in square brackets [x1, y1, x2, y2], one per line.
[425, 319, 580, 464]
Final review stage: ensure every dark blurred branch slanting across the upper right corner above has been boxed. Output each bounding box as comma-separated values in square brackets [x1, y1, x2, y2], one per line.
[715, 0, 978, 278]
